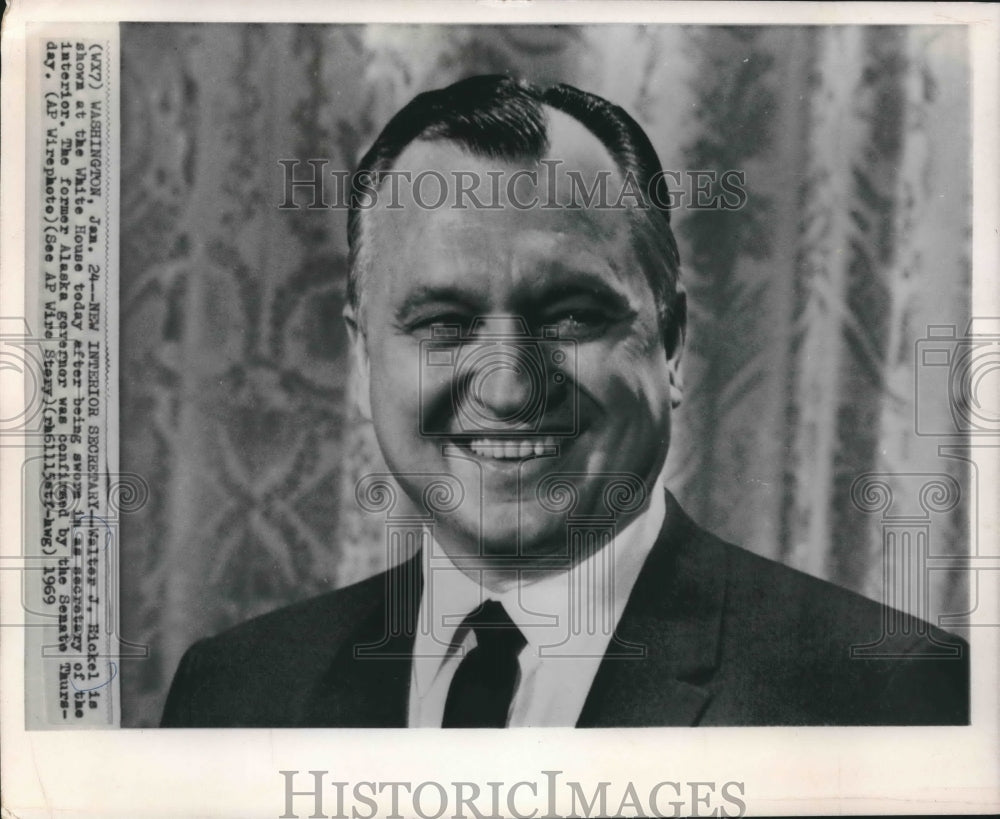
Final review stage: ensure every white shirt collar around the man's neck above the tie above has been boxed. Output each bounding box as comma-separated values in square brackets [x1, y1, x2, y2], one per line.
[414, 480, 666, 696]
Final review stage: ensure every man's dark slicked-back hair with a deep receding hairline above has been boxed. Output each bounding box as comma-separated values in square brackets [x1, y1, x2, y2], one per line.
[347, 75, 680, 346]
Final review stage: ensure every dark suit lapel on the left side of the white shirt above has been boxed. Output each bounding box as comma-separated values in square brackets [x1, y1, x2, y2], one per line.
[302, 553, 423, 728]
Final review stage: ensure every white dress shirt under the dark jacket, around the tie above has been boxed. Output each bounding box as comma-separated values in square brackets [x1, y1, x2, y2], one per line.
[408, 482, 666, 728]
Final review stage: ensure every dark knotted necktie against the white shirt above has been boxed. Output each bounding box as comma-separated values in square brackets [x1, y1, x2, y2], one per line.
[441, 600, 526, 728]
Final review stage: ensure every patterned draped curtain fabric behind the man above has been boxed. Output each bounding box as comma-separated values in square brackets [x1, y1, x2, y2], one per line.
[120, 24, 971, 726]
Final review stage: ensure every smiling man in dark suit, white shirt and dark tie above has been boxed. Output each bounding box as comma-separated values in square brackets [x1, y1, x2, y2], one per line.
[163, 77, 968, 727]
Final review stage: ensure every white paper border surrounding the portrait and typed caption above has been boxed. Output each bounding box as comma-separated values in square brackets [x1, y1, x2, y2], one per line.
[0, 0, 1000, 817]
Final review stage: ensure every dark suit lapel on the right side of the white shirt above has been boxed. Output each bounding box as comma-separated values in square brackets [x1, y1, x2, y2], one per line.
[577, 493, 726, 727]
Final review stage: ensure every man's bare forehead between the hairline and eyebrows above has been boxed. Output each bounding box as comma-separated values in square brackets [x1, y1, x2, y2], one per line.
[366, 103, 637, 304]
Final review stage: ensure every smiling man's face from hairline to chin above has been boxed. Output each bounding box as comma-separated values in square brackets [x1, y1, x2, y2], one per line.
[348, 112, 680, 565]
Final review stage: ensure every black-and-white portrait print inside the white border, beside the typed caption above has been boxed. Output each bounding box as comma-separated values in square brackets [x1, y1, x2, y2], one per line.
[120, 24, 971, 727]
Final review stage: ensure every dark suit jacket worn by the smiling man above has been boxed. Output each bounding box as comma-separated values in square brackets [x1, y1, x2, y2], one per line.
[162, 494, 969, 727]
